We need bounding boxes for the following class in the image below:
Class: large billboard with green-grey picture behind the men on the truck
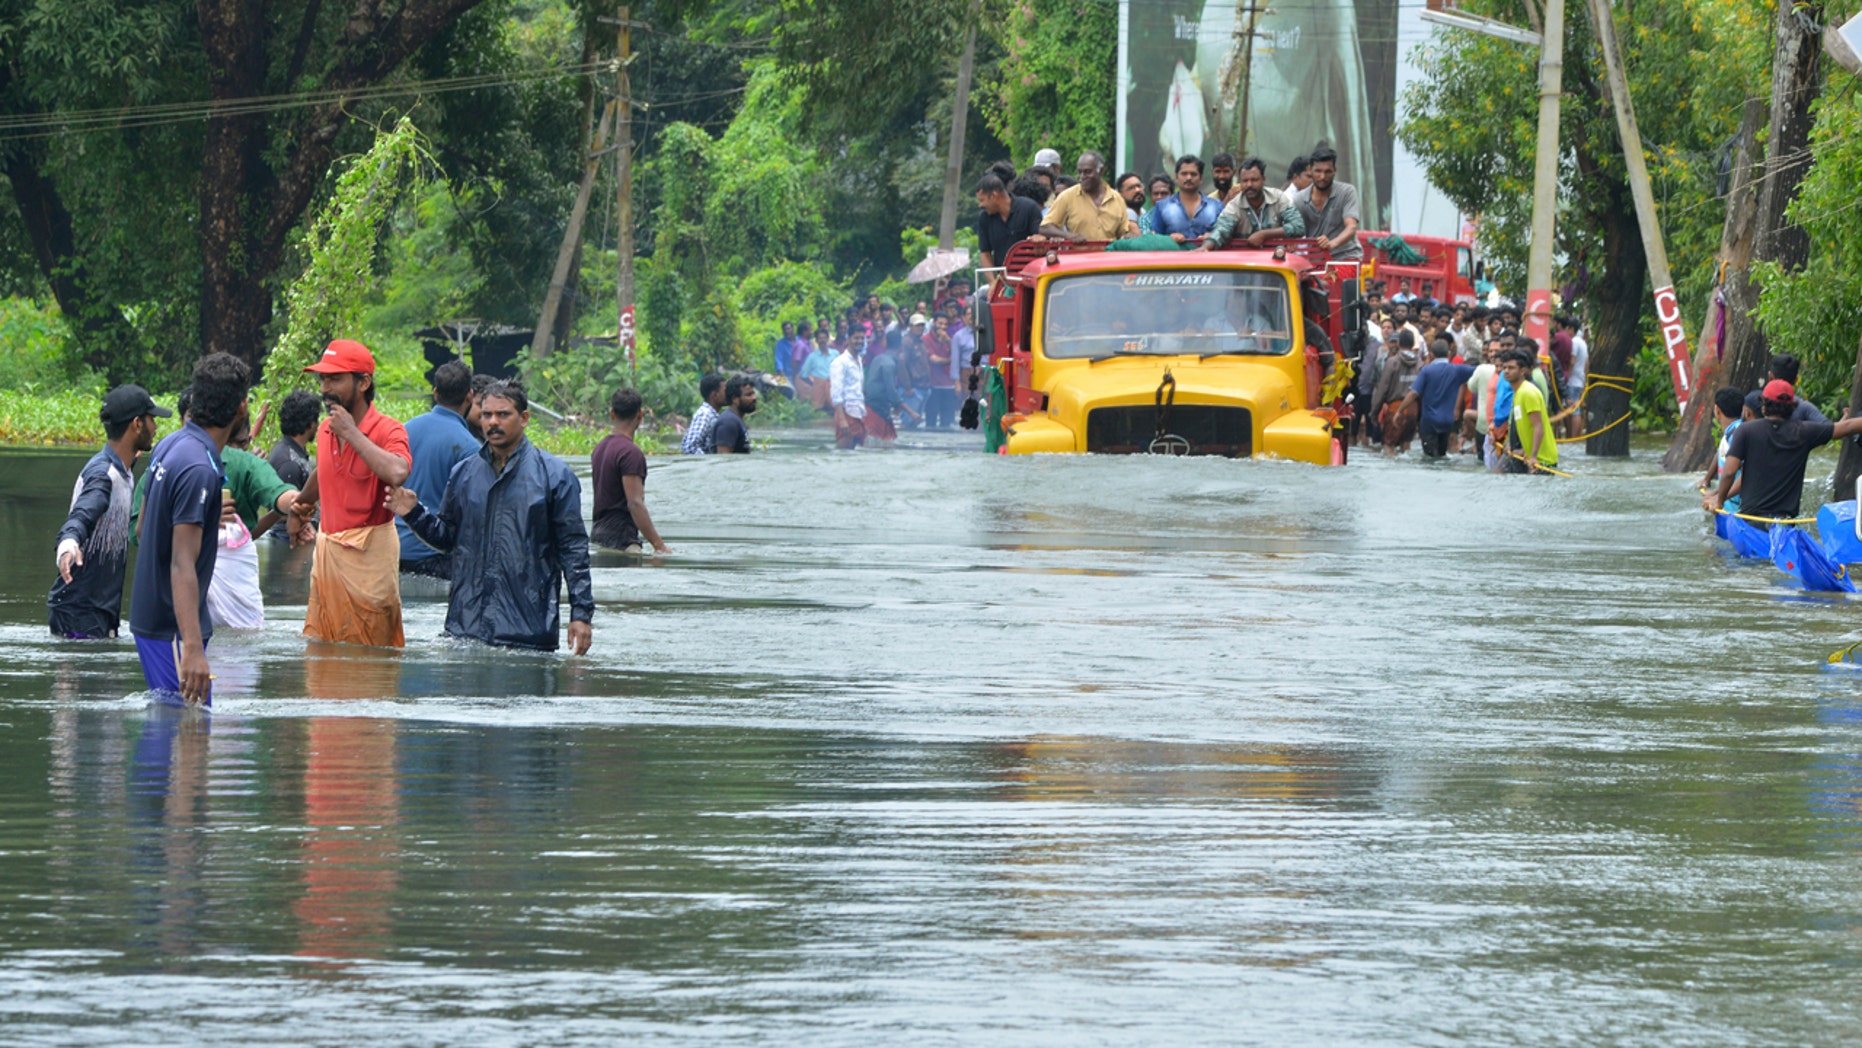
[1117,0,1398,229]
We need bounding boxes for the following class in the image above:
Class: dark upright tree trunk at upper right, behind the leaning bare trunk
[1720,4,1823,405]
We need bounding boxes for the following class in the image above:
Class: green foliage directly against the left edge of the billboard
[978,0,1119,164]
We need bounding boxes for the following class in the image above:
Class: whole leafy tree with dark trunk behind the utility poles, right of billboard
[1398,0,1763,454]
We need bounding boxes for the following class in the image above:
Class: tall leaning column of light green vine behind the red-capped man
[264,117,425,426]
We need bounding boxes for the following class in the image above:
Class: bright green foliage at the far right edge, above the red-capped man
[1754,89,1862,417]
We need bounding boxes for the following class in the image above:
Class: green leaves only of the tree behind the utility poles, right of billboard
[1397,0,1771,309]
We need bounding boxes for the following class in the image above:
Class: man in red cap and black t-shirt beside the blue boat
[1702,378,1862,521]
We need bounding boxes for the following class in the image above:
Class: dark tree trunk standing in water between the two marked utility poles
[1585,182,1648,458]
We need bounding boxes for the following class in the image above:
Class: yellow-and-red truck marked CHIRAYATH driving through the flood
[978,240,1372,465]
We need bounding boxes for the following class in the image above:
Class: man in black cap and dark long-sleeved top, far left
[45,385,173,640]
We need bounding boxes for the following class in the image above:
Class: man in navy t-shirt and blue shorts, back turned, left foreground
[128,354,251,705]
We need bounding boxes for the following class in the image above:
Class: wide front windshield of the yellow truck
[1043,270,1292,359]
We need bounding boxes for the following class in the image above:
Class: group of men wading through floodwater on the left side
[47,339,677,704]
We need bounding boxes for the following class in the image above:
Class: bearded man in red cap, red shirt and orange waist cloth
[292,339,413,648]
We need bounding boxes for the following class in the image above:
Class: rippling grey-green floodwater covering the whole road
[0,434,1862,1046]
